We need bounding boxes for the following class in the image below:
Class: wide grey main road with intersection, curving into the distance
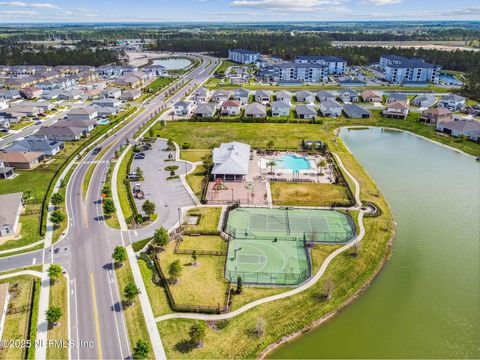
[0,52,218,359]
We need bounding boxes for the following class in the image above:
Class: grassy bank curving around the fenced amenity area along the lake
[154,119,394,358]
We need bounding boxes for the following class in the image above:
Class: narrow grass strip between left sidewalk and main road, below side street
[47,276,69,359]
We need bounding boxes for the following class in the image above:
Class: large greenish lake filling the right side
[270,128,480,358]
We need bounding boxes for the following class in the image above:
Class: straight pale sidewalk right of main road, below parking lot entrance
[127,245,167,360]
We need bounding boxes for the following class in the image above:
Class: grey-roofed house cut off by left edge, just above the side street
[0,192,23,237]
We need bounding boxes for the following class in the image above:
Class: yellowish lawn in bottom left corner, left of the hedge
[0,275,40,359]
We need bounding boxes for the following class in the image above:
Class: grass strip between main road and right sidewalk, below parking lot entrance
[115,260,150,348]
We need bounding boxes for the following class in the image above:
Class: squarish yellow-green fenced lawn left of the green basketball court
[158,243,228,306]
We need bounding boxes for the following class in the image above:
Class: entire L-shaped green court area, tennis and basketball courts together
[225,208,355,285]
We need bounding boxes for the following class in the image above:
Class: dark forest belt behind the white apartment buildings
[147,32,480,72]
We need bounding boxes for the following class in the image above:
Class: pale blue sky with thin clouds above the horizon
[0,0,480,23]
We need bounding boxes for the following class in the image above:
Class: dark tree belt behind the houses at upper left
[0,44,124,66]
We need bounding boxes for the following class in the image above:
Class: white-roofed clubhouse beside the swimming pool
[212,142,250,180]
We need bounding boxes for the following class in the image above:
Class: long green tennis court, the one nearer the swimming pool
[226,208,355,243]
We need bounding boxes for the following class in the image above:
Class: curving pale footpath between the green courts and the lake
[155,150,365,322]
